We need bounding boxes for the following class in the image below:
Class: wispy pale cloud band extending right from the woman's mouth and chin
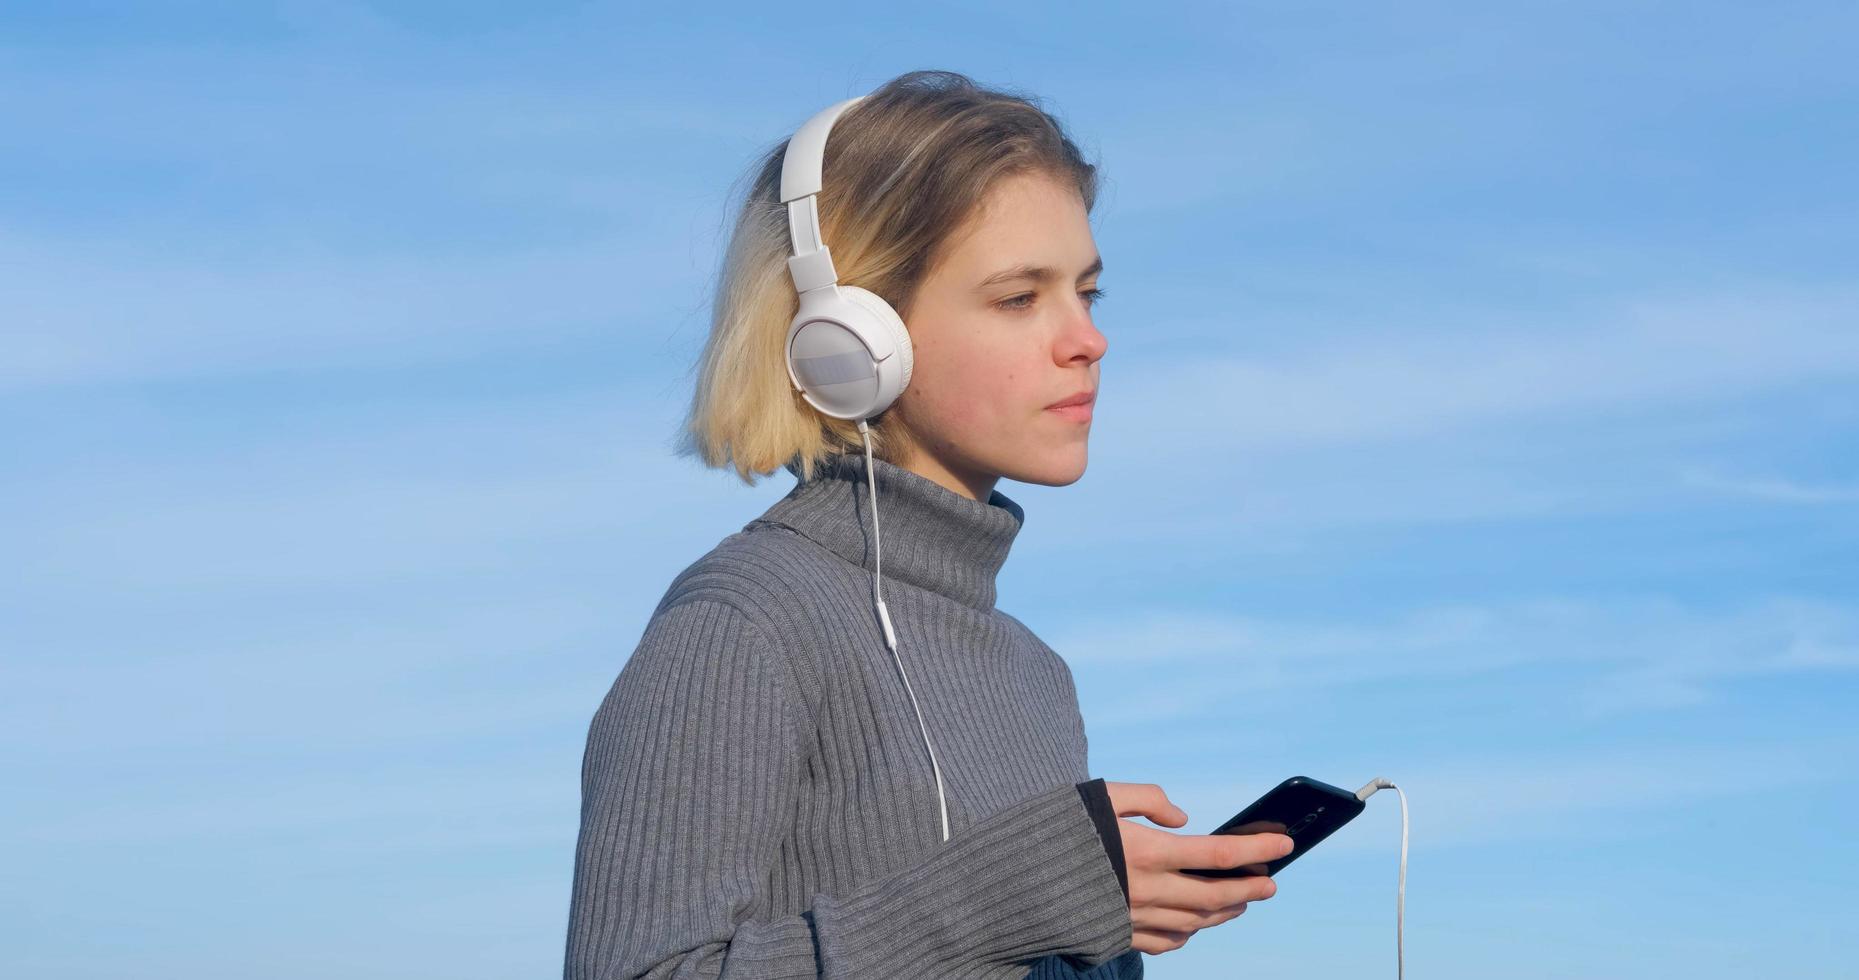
[1101,285,1859,452]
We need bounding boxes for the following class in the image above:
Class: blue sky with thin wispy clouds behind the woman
[0,2,1859,980]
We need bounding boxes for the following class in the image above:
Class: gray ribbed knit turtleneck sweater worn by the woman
[563,454,1143,980]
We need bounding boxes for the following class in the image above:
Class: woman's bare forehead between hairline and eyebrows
[937,173,1097,285]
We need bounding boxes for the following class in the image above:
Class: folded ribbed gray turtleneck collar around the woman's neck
[744,454,1026,610]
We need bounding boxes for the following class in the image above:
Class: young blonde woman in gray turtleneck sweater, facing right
[565,73,1290,980]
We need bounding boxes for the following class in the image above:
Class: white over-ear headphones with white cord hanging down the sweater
[781,95,948,841]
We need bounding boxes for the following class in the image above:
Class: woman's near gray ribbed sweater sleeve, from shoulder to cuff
[563,599,1132,980]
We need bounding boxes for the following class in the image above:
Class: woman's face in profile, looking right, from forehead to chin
[890,175,1108,500]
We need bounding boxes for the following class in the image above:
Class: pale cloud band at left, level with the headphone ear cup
[0,230,705,391]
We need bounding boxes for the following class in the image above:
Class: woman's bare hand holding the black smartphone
[1104,779,1294,954]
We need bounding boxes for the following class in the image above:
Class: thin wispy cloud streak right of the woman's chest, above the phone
[1050,597,1859,725]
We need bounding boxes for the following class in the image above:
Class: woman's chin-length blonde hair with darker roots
[677,71,1097,485]
